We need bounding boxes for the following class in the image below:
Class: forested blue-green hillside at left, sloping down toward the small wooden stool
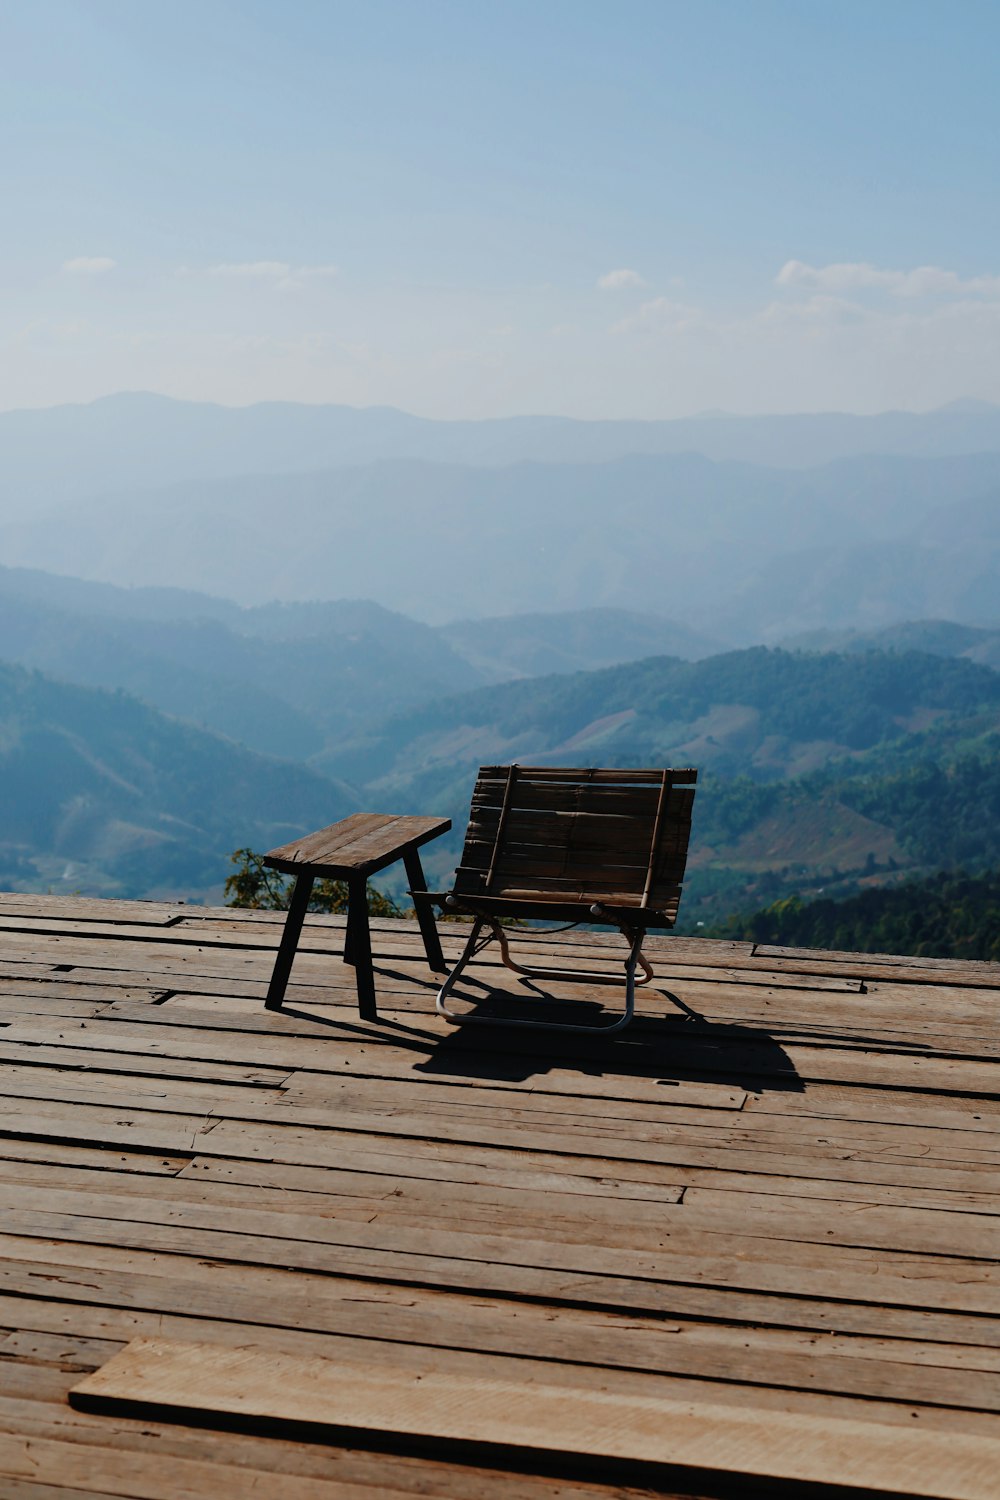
[0,665,357,899]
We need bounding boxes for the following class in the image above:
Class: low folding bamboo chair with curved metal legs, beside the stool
[412,765,697,1035]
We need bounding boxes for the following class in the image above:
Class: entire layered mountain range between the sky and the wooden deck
[0,396,1000,920]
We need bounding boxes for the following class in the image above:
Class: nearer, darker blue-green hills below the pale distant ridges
[0,572,1000,923]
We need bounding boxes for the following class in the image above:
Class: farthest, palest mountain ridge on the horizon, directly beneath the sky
[0,392,1000,509]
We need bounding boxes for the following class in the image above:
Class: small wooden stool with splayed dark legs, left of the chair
[264,813,451,1022]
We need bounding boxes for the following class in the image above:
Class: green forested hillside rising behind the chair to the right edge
[319,648,1000,932]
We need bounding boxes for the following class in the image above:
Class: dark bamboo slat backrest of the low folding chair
[454,765,697,927]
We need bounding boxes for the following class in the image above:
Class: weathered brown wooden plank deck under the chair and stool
[0,896,1000,1500]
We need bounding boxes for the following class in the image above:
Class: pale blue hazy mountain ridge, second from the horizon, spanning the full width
[0,453,1000,630]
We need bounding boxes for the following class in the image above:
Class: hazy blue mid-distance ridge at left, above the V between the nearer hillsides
[0,567,717,761]
